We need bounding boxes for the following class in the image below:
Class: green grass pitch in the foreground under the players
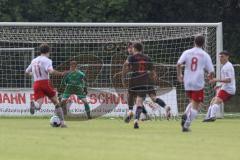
[0,118,240,160]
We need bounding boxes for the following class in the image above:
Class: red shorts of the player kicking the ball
[33,80,56,101]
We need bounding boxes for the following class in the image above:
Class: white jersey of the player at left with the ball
[26,55,53,81]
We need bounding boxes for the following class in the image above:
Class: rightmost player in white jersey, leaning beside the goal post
[203,51,236,122]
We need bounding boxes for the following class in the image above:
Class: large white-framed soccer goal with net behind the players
[0,22,222,116]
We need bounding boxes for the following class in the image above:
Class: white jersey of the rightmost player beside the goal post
[221,61,236,95]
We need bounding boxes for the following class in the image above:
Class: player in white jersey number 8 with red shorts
[177,35,214,132]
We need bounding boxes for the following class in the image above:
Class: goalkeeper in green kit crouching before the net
[61,61,91,119]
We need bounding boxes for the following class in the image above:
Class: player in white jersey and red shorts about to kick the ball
[25,43,66,128]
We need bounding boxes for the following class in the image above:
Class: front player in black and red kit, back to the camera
[127,43,170,129]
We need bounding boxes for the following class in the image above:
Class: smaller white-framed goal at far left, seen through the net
[0,46,34,90]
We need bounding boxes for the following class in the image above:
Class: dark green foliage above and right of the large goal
[0,0,240,55]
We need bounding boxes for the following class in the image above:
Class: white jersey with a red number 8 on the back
[178,47,214,91]
